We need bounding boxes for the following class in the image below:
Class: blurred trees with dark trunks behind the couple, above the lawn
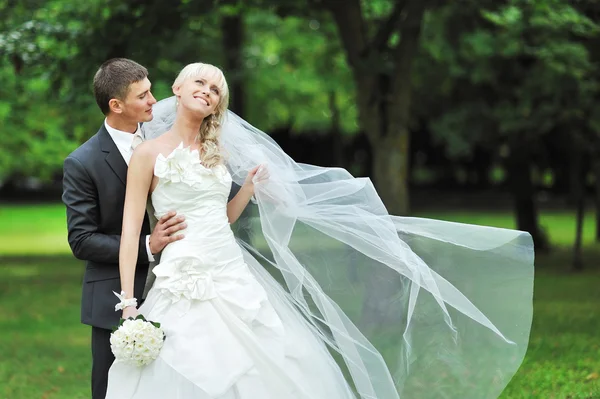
[0,0,600,265]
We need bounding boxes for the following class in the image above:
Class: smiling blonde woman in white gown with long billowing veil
[106,63,533,399]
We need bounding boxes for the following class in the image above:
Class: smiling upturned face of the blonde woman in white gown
[174,76,221,118]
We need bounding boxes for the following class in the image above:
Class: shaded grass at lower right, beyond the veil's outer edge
[502,268,600,399]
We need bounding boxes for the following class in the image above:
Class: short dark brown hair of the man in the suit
[94,58,148,115]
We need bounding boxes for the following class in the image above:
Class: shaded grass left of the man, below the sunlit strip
[0,256,91,399]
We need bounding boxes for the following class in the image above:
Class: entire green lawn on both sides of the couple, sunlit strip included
[0,205,600,399]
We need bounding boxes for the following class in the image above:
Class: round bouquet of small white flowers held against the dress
[110,315,165,367]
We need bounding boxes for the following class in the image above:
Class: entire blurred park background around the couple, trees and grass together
[0,0,600,399]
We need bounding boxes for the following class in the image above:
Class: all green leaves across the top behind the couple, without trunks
[0,0,600,191]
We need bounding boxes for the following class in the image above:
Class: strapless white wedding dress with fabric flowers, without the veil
[106,146,355,399]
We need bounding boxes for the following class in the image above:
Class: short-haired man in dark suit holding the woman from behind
[62,58,184,399]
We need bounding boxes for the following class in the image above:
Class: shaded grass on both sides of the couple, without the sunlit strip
[0,255,600,399]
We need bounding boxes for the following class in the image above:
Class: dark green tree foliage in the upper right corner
[416,0,600,159]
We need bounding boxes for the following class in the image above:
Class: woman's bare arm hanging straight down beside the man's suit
[119,142,156,306]
